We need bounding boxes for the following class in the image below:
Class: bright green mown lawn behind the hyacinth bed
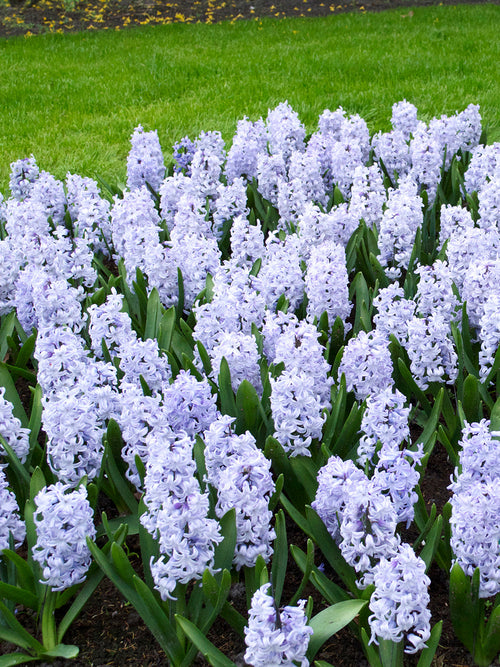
[0,5,500,193]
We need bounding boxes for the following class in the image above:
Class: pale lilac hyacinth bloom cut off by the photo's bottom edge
[245,584,313,667]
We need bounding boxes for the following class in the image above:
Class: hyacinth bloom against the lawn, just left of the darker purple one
[127,125,165,192]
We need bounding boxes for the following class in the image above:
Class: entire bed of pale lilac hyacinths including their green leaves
[0,101,500,667]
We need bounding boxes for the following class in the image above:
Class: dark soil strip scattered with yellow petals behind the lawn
[0,0,500,37]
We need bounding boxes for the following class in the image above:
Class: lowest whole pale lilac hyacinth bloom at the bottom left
[33,482,96,591]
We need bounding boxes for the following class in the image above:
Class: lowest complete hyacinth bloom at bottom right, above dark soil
[368,543,431,654]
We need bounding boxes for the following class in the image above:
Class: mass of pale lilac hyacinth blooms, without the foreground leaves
[0,101,500,667]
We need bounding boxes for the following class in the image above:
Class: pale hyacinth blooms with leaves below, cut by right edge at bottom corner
[449,419,500,667]
